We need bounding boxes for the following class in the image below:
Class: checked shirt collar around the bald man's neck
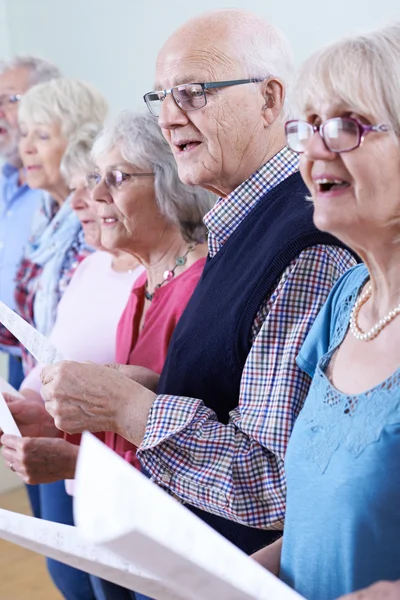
[204,147,299,257]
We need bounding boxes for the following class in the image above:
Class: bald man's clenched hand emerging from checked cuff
[41,361,155,446]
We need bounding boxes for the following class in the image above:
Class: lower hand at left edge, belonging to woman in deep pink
[1,435,79,484]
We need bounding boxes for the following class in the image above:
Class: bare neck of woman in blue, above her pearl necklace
[356,242,400,320]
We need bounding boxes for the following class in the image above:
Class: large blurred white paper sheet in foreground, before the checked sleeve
[74,433,301,600]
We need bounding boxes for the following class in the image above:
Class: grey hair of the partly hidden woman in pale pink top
[60,123,102,183]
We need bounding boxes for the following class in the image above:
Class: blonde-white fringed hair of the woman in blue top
[295,22,400,136]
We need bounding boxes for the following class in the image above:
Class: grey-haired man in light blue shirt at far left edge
[0,57,60,389]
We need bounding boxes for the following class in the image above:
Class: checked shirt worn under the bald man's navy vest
[138,148,355,529]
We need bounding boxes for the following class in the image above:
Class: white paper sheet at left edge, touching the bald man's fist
[0,302,63,365]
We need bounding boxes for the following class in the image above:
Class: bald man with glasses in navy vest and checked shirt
[43,10,355,553]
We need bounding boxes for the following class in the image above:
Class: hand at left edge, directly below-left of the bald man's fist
[0,393,60,437]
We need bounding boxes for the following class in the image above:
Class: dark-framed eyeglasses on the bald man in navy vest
[143,79,264,117]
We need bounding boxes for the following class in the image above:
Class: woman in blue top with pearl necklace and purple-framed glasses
[254,23,400,600]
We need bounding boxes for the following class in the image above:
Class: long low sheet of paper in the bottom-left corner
[0,509,186,600]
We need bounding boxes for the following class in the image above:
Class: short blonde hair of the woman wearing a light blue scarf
[18,77,108,141]
